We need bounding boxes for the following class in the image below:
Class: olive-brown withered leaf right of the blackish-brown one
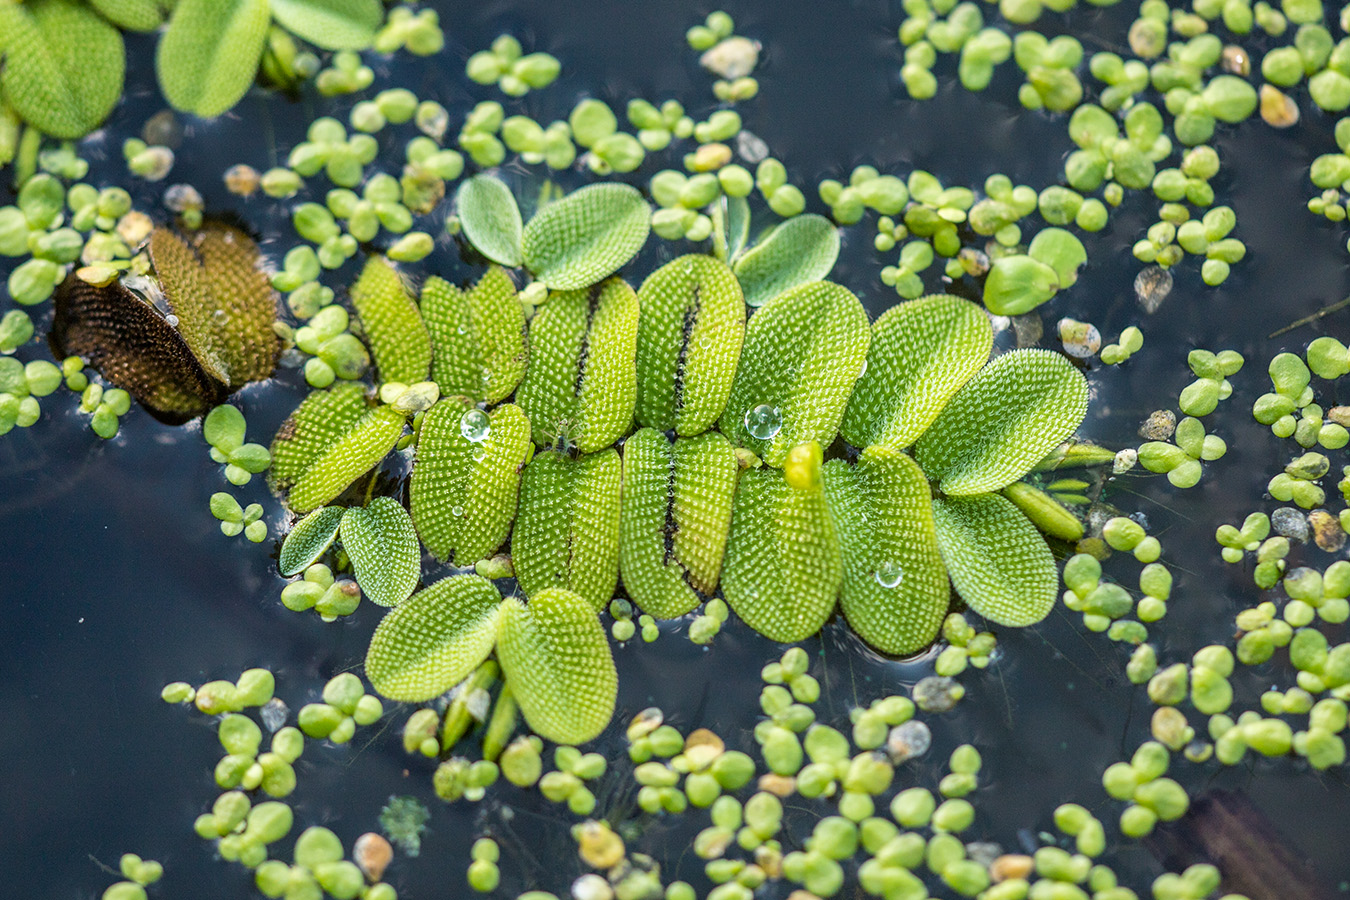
[150,221,281,390]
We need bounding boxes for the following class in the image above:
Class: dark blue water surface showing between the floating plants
[0,0,1350,899]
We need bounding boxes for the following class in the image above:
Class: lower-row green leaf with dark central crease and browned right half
[620,428,740,619]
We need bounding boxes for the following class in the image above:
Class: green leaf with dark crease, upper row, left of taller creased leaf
[516,278,639,453]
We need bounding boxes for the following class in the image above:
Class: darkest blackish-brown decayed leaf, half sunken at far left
[49,274,225,425]
